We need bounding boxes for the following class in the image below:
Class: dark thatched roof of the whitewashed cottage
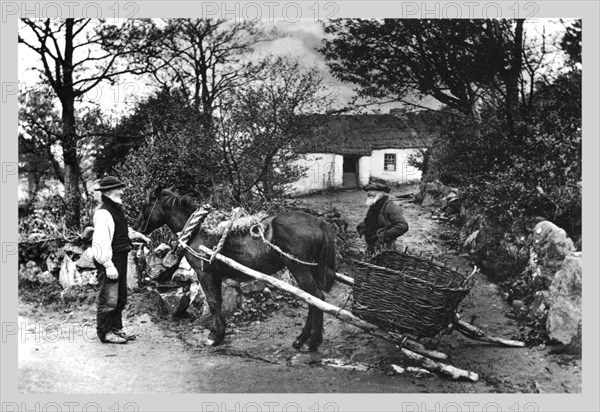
[297,113,438,156]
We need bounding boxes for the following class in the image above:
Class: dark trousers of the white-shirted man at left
[96,252,128,339]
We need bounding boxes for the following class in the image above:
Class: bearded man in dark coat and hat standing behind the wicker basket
[356,183,408,254]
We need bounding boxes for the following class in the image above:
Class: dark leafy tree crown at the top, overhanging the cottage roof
[320,19,522,115]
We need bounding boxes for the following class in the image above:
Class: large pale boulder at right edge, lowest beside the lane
[546,252,582,345]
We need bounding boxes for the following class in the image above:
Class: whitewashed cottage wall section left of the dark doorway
[291,153,344,194]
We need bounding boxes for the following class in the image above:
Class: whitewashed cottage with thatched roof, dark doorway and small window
[292,110,437,194]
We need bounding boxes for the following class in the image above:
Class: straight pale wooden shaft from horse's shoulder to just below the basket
[198,245,448,360]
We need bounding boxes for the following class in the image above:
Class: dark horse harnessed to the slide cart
[135,187,335,351]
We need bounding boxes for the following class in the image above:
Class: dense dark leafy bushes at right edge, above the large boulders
[434,72,582,241]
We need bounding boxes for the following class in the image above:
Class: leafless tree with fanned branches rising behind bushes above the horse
[138,19,270,134]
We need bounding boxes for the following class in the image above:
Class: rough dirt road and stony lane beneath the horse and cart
[19,186,582,393]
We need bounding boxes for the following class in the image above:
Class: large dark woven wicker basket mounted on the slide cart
[352,250,473,338]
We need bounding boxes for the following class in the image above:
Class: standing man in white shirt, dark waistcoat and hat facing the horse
[92,176,150,343]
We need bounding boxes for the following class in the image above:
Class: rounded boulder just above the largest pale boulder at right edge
[530,220,575,278]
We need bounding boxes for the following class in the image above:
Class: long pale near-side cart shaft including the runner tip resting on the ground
[188,245,488,382]
